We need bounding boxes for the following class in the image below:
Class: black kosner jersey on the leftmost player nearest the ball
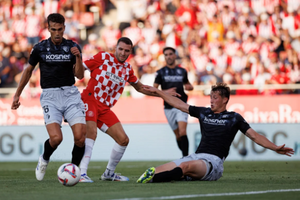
[29,38,81,88]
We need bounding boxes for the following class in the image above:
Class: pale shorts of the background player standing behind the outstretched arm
[164,108,189,131]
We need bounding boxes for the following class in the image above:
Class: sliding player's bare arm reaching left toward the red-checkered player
[144,85,190,113]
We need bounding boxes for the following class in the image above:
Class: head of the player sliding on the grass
[210,83,230,113]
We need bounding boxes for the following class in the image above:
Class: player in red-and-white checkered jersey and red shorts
[80,37,164,183]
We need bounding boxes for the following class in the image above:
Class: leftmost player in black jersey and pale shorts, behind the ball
[11,13,86,181]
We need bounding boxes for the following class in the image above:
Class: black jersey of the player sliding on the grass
[189,106,250,159]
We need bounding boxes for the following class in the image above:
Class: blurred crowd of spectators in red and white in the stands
[0,0,300,97]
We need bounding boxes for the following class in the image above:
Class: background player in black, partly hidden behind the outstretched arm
[153,47,194,156]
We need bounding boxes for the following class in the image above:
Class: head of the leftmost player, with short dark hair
[47,13,65,44]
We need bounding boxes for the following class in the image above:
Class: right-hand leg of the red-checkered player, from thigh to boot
[101,122,129,181]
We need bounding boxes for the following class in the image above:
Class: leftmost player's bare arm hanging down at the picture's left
[11,64,34,110]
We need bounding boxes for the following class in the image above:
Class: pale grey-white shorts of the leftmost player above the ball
[40,86,85,126]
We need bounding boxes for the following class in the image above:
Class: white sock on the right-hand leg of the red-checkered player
[105,143,127,175]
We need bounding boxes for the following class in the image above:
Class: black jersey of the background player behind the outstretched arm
[154,66,189,109]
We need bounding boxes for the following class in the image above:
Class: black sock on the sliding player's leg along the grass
[152,167,183,183]
